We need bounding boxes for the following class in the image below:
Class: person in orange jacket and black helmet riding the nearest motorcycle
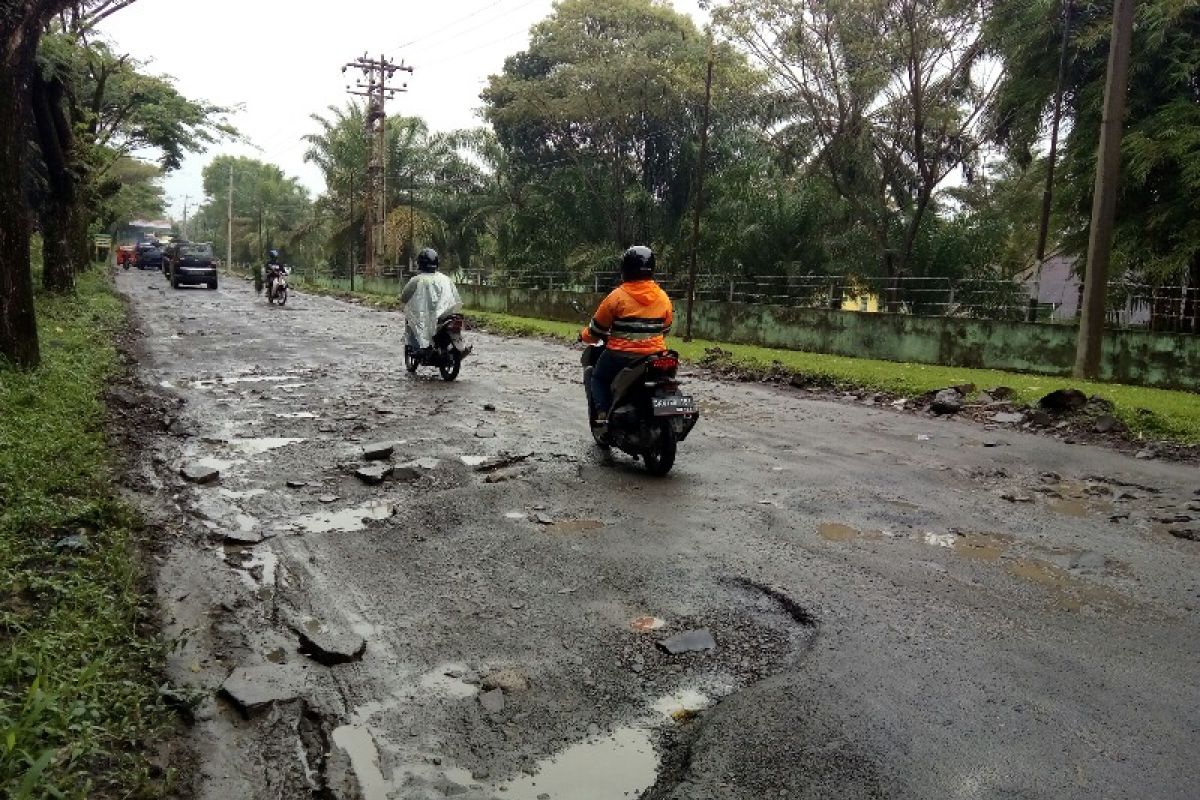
[580,246,674,423]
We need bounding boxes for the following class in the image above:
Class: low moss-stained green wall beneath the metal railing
[460,284,1200,391]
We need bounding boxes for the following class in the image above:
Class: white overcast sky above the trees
[103,0,706,217]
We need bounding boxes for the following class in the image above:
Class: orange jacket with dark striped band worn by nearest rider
[582,281,673,355]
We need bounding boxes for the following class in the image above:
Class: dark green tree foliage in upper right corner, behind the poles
[988,0,1200,285]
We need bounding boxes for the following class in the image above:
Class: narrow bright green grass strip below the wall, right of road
[290,282,1200,445]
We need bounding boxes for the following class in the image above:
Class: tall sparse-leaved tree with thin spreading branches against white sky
[714,0,996,287]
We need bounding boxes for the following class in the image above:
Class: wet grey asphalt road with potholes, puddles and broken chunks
[118,272,1200,800]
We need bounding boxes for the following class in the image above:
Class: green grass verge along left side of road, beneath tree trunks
[0,269,172,798]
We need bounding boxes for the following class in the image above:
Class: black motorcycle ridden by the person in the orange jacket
[582,347,700,475]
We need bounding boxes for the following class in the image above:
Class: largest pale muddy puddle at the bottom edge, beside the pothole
[502,728,659,800]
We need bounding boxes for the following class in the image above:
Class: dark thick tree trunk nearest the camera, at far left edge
[0,14,41,369]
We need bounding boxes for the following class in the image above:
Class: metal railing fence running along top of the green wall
[283,266,1200,333]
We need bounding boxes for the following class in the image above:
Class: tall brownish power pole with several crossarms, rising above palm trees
[342,53,413,276]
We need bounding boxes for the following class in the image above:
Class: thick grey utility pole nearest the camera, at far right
[1075,0,1135,378]
